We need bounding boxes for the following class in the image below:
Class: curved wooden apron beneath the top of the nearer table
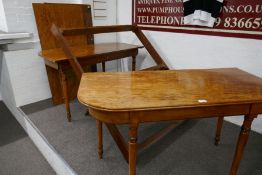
[89,104,254,124]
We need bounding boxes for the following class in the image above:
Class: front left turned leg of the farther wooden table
[59,68,71,122]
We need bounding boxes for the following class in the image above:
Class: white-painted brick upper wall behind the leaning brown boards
[0,0,116,42]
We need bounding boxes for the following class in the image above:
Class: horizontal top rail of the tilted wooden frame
[62,25,135,36]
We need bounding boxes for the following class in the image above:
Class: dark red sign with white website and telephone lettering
[133,0,262,39]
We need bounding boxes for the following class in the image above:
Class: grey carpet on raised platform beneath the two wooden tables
[24,101,262,175]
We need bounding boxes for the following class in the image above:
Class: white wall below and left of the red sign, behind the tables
[118,1,262,133]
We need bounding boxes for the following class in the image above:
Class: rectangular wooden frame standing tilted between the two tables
[51,24,173,160]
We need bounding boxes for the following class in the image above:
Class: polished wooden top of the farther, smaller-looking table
[39,43,142,63]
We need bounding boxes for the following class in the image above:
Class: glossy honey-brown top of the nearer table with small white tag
[78,68,262,111]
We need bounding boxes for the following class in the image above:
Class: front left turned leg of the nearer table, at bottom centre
[128,124,138,175]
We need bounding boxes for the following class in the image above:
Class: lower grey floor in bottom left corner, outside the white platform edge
[0,102,55,175]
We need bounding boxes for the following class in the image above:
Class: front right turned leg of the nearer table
[230,115,256,175]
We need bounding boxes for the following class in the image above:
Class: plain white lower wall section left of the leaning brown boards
[2,49,51,106]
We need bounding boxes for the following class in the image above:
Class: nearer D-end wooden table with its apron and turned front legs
[78,68,262,175]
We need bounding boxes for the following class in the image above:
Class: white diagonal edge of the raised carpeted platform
[4,101,77,175]
